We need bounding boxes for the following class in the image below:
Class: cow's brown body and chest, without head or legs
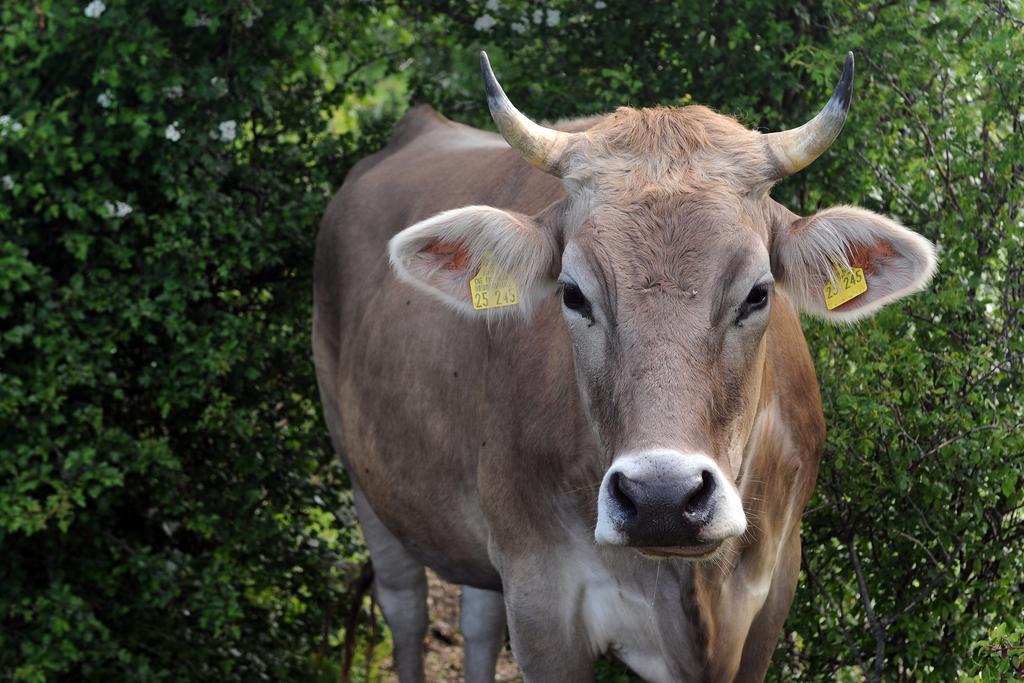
[315,108,824,681]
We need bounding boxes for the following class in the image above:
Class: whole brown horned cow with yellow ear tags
[313,53,936,683]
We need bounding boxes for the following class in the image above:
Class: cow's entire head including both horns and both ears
[390,54,935,557]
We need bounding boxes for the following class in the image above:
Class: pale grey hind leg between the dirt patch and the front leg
[459,586,505,683]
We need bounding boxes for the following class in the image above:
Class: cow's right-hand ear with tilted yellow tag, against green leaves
[771,206,936,322]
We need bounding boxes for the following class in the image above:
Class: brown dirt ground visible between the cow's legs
[380,570,522,683]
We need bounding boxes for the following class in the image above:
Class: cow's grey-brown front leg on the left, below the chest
[505,577,594,683]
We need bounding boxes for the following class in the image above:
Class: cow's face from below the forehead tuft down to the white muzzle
[558,183,775,556]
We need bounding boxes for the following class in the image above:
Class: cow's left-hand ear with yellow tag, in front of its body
[388,206,558,315]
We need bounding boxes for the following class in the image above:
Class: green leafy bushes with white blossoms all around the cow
[0,0,1024,681]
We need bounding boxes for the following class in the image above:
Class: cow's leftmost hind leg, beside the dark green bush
[353,486,428,683]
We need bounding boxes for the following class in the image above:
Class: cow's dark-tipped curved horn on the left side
[480,51,578,176]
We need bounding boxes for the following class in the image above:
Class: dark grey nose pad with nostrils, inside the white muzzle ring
[606,469,715,547]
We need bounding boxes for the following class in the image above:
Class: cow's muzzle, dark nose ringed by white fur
[594,451,746,557]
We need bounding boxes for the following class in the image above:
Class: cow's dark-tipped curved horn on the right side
[765,52,853,178]
